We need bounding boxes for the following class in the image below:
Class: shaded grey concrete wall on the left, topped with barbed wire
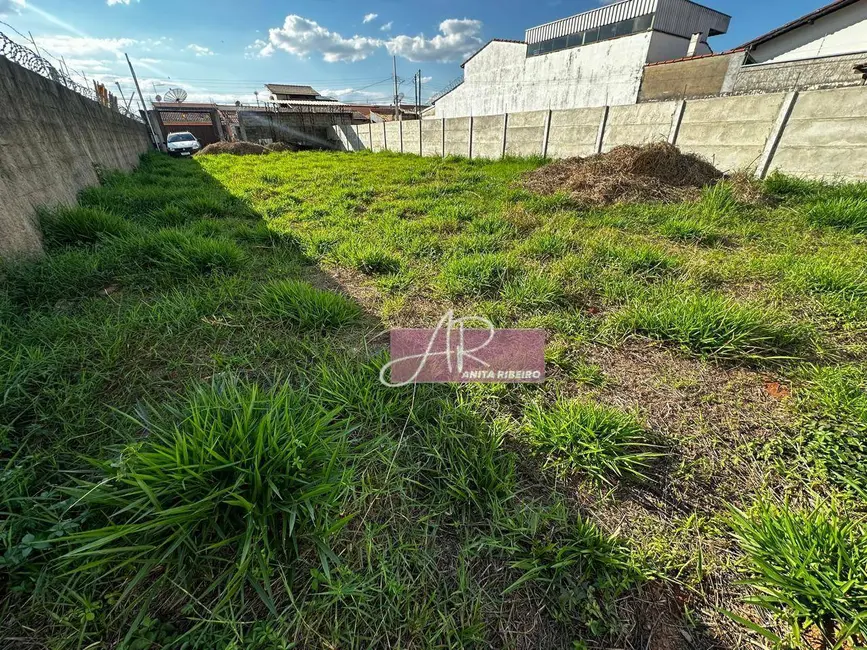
[0,56,151,255]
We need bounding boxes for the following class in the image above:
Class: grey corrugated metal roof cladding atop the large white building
[525,0,731,44]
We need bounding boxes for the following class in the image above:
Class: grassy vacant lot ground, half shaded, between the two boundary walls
[0,153,867,650]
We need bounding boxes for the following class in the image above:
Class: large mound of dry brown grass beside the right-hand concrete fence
[523,142,724,205]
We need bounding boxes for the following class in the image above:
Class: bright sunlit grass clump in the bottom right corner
[731,501,867,648]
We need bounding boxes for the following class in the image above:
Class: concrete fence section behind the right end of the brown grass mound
[680,93,785,171]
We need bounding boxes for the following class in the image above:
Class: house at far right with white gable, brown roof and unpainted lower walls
[639,0,867,101]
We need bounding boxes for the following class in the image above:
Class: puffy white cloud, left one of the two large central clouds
[259,14,383,63]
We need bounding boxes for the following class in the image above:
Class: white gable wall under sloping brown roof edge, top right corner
[750,0,867,63]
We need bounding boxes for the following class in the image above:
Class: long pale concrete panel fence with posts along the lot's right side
[332,88,867,181]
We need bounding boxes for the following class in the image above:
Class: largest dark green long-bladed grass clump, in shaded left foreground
[61,380,349,613]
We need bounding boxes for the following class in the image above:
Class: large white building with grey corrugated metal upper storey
[434,0,731,118]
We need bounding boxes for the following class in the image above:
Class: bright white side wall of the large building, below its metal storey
[436,32,656,118]
